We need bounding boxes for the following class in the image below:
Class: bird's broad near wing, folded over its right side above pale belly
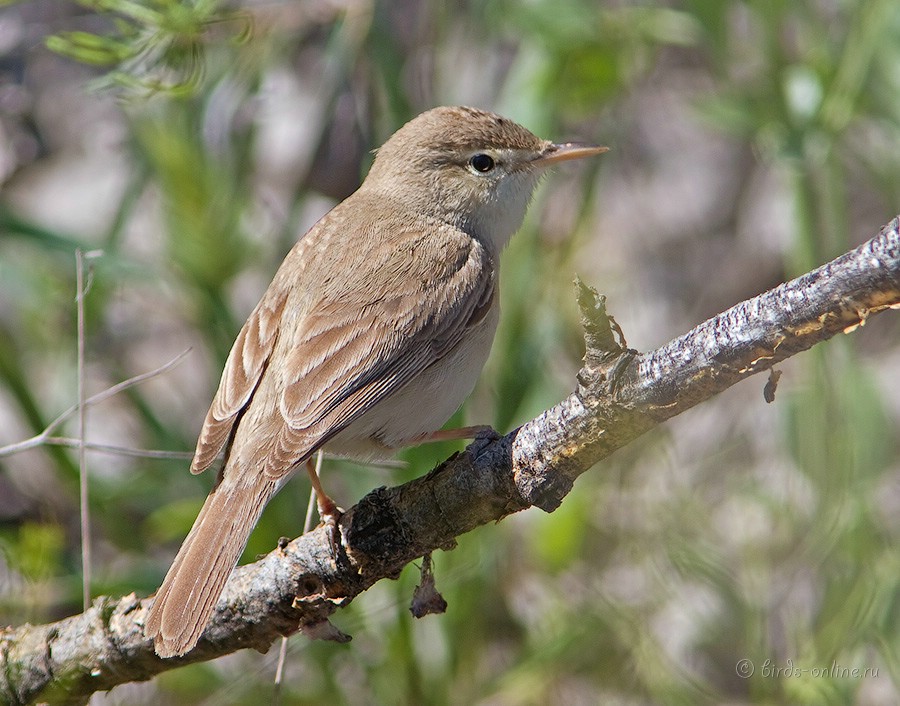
[264,226,494,476]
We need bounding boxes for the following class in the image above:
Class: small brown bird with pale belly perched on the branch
[145,108,606,657]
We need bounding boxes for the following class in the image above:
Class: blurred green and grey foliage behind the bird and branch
[0,0,900,706]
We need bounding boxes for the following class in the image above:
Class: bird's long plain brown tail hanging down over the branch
[144,474,279,657]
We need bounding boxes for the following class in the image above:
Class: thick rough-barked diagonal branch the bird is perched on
[0,214,900,704]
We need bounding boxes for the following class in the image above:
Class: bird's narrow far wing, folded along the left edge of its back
[191,287,288,473]
